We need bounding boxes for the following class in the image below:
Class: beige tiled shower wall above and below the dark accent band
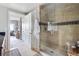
[40,3,79,55]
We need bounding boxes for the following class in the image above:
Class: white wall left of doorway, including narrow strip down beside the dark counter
[0,6,9,51]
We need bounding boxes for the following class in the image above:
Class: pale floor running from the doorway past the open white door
[10,36,36,56]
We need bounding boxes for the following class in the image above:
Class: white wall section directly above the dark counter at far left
[0,6,8,32]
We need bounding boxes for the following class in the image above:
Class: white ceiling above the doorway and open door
[0,3,42,13]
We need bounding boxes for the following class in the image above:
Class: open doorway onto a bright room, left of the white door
[8,11,22,49]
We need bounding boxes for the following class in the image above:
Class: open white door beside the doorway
[22,13,31,48]
